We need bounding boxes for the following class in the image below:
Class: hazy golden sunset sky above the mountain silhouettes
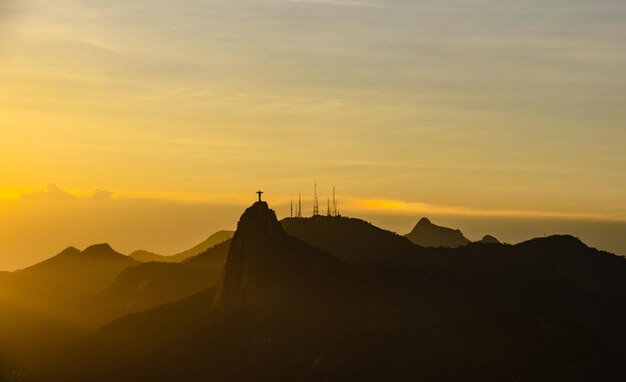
[0,0,626,270]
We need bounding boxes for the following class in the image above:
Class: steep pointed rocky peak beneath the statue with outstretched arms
[214,202,340,310]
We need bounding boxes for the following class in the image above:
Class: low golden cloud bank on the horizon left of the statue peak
[0,185,244,270]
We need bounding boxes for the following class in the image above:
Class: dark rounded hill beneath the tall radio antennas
[281,216,417,264]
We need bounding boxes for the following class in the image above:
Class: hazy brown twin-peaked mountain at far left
[15,244,138,292]
